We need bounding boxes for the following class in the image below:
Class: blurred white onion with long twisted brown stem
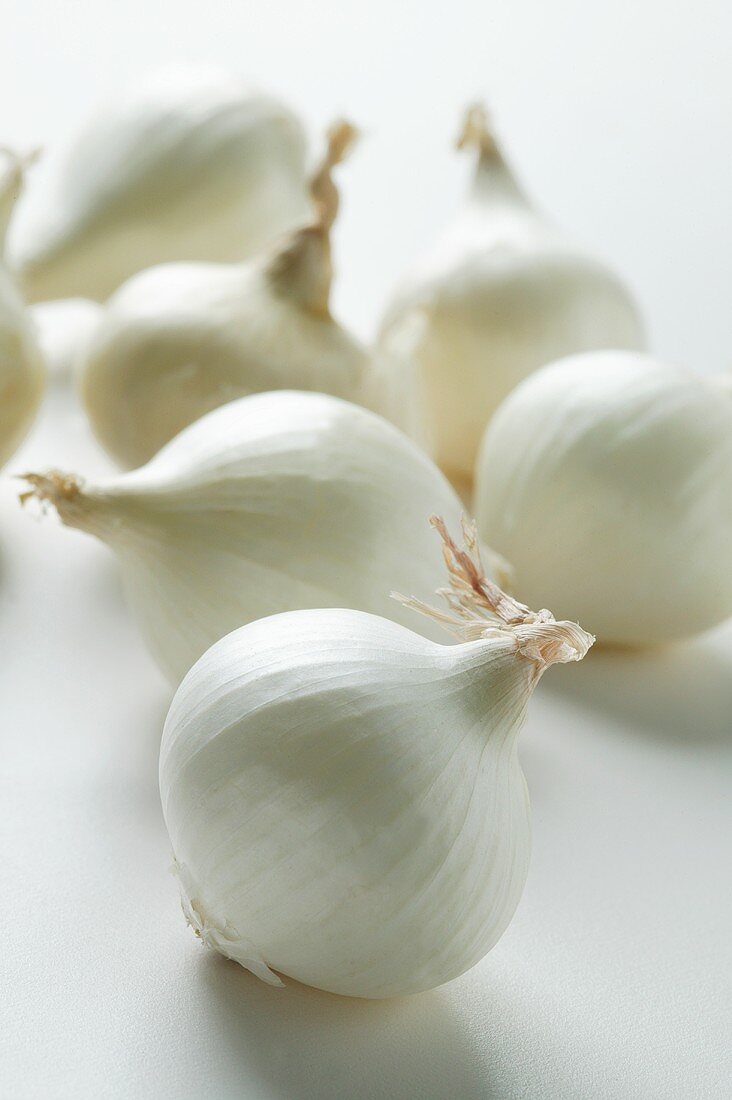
[78,122,369,468]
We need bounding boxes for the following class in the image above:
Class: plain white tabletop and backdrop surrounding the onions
[0,0,732,1100]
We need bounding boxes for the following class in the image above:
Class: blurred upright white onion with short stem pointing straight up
[380,107,644,491]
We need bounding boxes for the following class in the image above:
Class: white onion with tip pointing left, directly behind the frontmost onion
[24,391,499,683]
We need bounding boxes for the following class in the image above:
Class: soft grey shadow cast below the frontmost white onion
[199,952,494,1100]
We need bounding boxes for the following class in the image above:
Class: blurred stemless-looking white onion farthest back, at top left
[11,66,308,301]
